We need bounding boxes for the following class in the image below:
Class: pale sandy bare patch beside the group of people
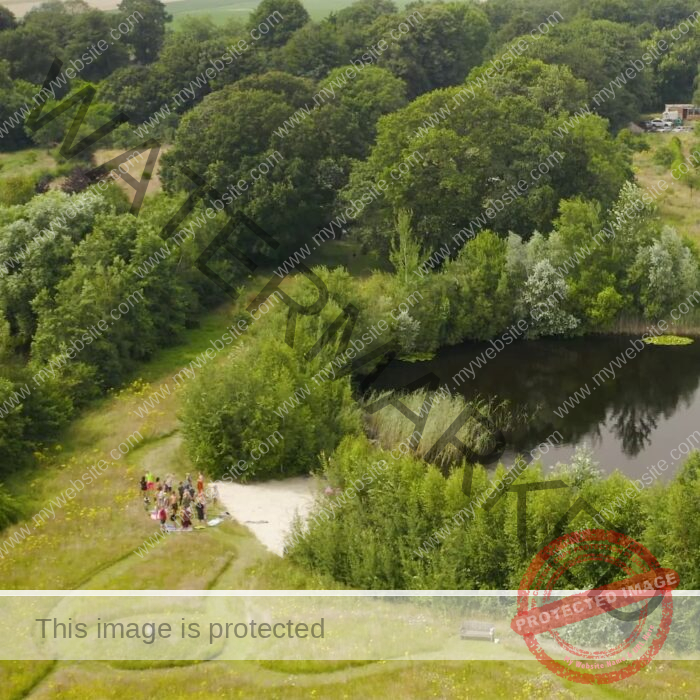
[216,476,317,556]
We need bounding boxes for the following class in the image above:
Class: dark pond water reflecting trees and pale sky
[372,336,700,477]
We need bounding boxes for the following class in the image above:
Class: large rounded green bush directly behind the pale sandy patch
[183,337,359,481]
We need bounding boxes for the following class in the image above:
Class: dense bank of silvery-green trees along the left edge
[0,186,235,470]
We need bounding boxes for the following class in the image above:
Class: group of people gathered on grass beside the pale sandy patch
[140,472,207,530]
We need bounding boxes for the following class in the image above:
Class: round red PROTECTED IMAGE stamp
[511,530,680,683]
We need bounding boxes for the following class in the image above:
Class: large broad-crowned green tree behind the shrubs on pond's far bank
[341,60,631,249]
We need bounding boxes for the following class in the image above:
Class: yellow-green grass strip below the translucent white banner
[1,661,697,700]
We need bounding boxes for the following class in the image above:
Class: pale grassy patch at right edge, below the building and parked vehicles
[634,132,700,244]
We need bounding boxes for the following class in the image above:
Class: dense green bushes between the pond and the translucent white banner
[290,438,700,590]
